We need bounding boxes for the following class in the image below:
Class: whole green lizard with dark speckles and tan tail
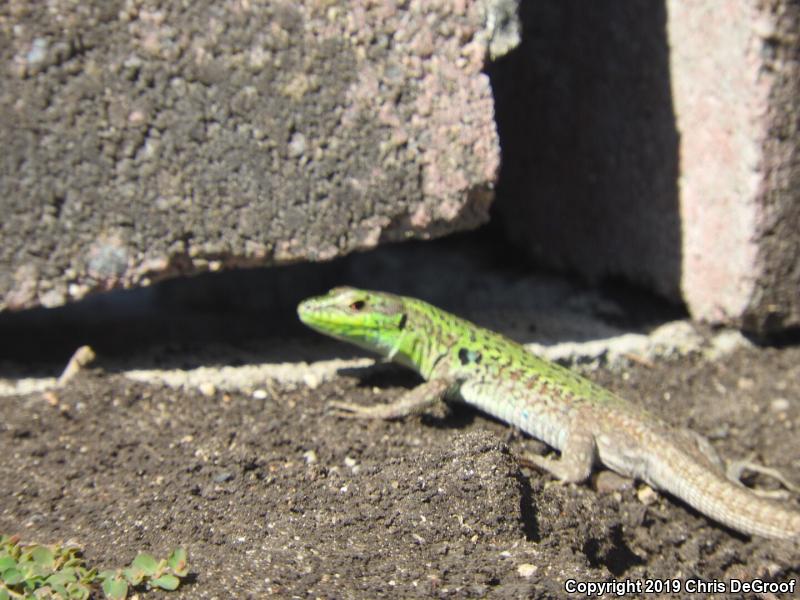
[297,287,800,540]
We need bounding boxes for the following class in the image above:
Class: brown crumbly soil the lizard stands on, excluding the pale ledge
[0,340,800,598]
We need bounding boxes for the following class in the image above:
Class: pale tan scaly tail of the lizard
[652,455,800,540]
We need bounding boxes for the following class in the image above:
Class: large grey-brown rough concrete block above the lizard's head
[0,0,518,310]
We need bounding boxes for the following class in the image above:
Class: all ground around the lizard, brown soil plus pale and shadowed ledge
[0,237,800,598]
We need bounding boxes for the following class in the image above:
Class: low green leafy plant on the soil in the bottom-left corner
[0,535,189,600]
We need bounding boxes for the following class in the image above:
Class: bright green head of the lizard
[297,287,407,359]
